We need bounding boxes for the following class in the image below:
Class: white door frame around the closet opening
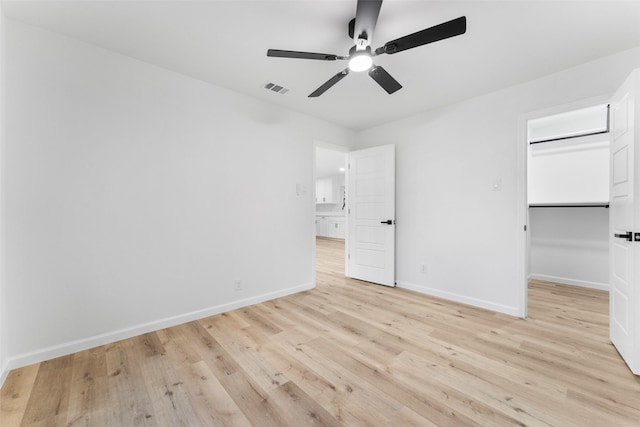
[517,96,610,318]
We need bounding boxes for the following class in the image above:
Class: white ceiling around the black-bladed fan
[2,0,640,130]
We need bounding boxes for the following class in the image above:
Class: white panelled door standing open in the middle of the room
[346,145,396,286]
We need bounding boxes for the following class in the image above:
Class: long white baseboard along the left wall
[0,283,315,376]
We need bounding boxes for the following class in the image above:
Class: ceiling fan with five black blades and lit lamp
[267,0,467,98]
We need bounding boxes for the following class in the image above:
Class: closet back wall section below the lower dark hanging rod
[529,207,609,289]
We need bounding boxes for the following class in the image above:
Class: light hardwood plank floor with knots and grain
[0,239,640,427]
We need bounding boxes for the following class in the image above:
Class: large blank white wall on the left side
[3,20,354,368]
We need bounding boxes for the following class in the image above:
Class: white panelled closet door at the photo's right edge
[609,70,640,375]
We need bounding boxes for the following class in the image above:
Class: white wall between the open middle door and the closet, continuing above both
[358,48,640,315]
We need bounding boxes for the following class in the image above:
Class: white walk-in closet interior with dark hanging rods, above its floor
[527,104,609,289]
